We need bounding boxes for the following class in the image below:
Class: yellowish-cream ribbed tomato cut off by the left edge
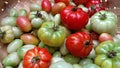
[0,25,15,43]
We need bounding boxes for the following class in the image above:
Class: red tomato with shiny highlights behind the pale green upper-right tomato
[86,0,105,16]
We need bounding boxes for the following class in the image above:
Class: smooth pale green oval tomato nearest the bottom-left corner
[3,52,20,67]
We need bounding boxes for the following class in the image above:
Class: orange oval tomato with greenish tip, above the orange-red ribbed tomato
[20,34,39,45]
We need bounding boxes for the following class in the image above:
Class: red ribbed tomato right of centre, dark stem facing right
[66,32,92,58]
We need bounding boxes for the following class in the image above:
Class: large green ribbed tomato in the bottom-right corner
[94,40,120,68]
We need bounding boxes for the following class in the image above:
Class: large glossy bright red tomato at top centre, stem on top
[60,6,89,30]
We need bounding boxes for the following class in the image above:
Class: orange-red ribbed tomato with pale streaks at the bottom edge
[23,47,52,68]
